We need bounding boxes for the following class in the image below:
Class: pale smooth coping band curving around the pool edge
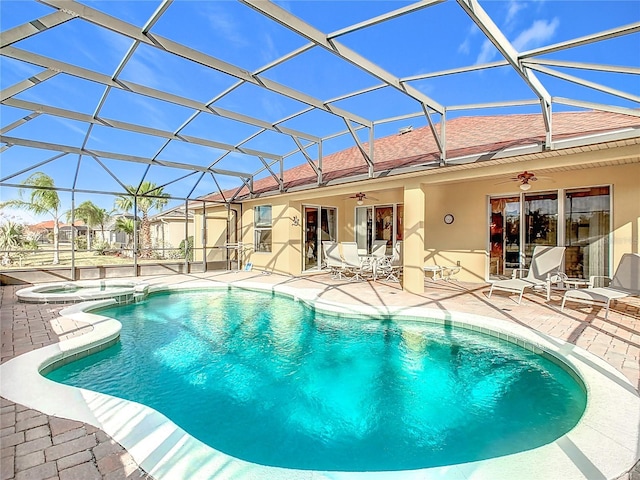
[0,281,640,480]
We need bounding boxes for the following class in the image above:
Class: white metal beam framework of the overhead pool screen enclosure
[0,0,640,274]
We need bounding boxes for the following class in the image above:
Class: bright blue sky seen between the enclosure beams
[0,0,640,223]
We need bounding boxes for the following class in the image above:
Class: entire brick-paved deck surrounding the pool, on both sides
[0,272,640,480]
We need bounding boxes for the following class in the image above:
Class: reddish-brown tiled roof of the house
[204,111,640,200]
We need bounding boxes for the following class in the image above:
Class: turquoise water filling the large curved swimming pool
[47,290,586,471]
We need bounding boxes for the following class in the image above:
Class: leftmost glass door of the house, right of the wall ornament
[302,206,338,271]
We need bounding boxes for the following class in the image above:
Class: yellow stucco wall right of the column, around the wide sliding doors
[425,163,640,281]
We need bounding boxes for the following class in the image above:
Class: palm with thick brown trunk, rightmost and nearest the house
[116,181,169,258]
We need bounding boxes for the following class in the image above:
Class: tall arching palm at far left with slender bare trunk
[0,172,61,265]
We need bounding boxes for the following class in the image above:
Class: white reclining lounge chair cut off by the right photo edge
[561,253,640,320]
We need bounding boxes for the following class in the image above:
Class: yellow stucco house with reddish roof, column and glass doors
[195,111,640,292]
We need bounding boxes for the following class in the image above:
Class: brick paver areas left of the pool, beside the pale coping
[0,286,151,480]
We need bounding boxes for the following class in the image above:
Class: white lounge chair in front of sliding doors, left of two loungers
[489,245,565,305]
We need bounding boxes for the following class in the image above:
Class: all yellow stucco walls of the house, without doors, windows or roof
[202,147,640,282]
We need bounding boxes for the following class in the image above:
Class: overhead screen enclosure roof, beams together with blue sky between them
[0,0,640,208]
